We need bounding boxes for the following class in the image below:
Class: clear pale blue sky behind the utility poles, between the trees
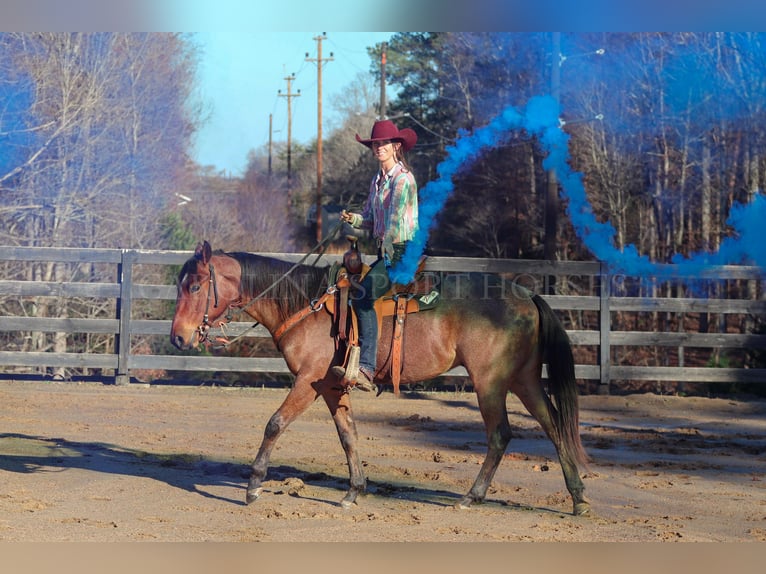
[191,31,392,177]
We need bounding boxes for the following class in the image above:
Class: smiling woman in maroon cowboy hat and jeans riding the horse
[334,120,418,391]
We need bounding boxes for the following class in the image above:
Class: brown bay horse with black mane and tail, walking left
[170,241,590,516]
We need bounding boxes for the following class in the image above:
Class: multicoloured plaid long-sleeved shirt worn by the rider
[354,162,418,243]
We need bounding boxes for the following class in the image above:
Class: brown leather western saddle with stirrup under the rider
[325,236,439,396]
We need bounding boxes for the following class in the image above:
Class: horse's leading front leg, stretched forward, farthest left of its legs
[245,376,318,504]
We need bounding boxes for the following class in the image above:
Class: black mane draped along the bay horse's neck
[226,252,328,319]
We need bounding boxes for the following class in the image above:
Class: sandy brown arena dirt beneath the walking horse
[0,381,766,542]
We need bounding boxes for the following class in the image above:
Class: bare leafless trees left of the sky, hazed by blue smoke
[0,33,201,380]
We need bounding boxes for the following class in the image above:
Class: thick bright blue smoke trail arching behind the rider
[391,96,766,284]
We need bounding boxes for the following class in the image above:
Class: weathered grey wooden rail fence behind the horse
[0,247,766,393]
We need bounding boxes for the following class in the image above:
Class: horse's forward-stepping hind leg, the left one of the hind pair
[457,387,511,508]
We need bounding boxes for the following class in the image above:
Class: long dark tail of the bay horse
[532,295,588,466]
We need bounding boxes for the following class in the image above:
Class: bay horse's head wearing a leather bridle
[170,241,241,349]
